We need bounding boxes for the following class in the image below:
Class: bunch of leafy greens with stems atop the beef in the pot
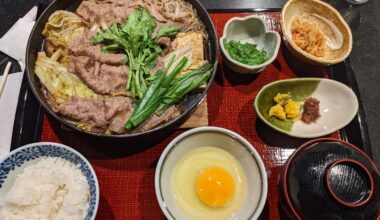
[91,7,180,99]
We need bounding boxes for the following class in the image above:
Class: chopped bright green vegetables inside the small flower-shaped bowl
[224,40,268,65]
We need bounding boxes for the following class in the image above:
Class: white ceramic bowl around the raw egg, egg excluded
[155,127,268,220]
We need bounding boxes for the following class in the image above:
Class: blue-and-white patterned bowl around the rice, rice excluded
[0,142,100,220]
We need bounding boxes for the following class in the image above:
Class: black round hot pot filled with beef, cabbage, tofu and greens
[26,0,218,141]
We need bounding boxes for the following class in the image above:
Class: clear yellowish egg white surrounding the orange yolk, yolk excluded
[171,147,247,220]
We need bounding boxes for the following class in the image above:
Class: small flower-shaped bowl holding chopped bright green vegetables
[219,16,281,73]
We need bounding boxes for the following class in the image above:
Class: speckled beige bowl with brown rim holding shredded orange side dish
[281,0,352,66]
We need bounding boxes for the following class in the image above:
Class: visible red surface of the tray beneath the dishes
[37,12,339,220]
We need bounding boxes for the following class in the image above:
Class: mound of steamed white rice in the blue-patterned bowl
[0,158,90,220]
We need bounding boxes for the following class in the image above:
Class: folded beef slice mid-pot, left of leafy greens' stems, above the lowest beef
[68,56,128,95]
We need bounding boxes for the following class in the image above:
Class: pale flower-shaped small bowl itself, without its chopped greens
[219,16,281,73]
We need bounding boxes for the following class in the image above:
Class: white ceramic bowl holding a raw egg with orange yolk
[155,127,268,220]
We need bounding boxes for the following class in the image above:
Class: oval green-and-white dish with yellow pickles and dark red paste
[254,78,358,138]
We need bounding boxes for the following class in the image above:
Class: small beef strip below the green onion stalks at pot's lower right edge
[134,105,179,133]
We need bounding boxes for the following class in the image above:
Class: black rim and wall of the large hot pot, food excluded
[26,0,219,143]
